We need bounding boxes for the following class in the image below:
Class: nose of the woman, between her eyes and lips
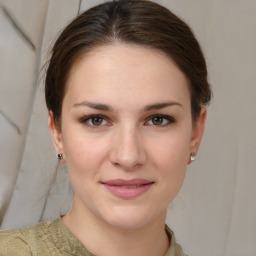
[110,127,147,171]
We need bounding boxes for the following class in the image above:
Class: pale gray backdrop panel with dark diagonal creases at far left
[0,0,48,222]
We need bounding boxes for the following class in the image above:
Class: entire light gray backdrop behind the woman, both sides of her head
[0,0,256,256]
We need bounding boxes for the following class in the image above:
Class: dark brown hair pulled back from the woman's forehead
[45,0,211,127]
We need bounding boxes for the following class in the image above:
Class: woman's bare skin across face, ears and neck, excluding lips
[49,44,206,256]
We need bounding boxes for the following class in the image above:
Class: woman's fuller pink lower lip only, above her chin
[104,183,153,199]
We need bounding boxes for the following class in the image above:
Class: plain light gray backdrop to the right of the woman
[162,0,256,256]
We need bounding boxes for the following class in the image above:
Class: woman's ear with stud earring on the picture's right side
[188,107,207,164]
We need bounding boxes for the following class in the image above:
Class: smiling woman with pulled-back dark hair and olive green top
[0,0,211,256]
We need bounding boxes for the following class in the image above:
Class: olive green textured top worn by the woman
[0,218,186,256]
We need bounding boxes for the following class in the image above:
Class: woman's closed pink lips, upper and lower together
[102,179,154,199]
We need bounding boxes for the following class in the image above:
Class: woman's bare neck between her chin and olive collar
[62,195,169,256]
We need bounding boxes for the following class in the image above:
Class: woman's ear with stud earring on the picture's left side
[48,111,65,162]
